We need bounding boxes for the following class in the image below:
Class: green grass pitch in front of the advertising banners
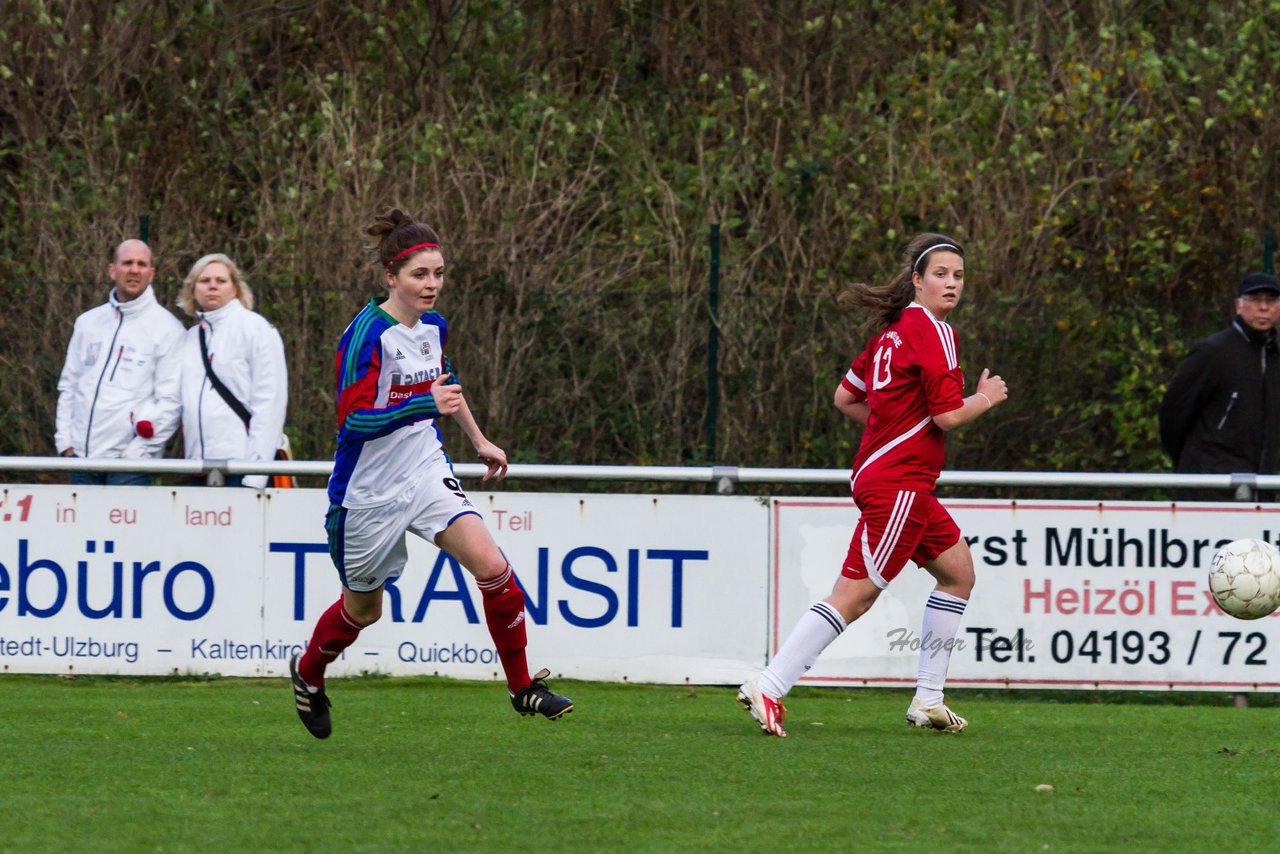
[0,676,1280,851]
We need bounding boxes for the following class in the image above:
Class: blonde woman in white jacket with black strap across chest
[178,254,288,488]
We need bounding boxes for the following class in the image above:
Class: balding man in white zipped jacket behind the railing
[54,239,183,485]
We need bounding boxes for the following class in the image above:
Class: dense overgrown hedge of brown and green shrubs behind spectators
[0,0,1280,481]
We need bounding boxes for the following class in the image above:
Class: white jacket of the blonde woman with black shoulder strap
[182,298,289,487]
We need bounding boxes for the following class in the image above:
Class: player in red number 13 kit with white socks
[737,234,1009,736]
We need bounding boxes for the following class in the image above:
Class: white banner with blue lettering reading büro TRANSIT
[0,485,769,682]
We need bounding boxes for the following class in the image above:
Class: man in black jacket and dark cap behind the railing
[1160,273,1280,501]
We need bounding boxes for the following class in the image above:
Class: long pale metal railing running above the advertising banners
[0,457,1280,494]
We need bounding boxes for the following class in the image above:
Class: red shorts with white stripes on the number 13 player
[840,490,960,590]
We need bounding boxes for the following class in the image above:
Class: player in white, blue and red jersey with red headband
[289,210,573,739]
